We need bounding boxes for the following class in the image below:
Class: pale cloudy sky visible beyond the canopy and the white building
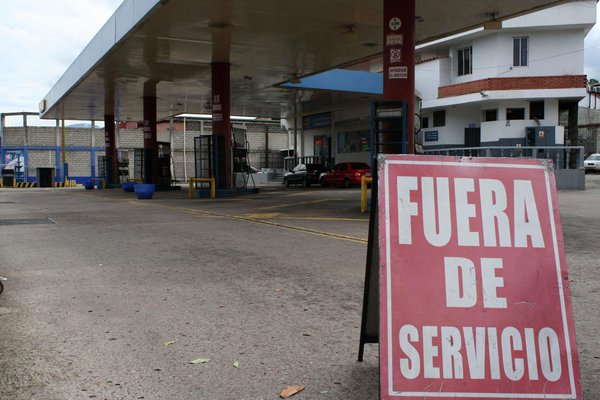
[0,0,600,125]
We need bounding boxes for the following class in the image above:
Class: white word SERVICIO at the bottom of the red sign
[398,325,562,382]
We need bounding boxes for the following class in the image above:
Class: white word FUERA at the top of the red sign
[397,176,544,248]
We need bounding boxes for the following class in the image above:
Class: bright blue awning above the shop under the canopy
[280,69,383,95]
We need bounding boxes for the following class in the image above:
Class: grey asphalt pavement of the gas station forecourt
[0,175,600,400]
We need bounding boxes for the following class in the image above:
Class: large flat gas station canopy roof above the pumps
[40,0,566,121]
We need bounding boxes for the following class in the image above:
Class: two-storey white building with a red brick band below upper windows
[416,1,596,149]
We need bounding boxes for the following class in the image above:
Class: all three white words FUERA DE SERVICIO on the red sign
[397,176,562,382]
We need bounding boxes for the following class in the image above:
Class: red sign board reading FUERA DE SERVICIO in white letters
[379,155,582,399]
